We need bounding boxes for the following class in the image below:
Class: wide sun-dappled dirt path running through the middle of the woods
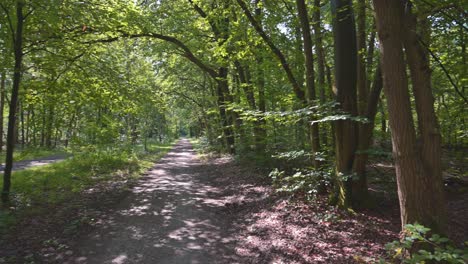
[66,139,245,264]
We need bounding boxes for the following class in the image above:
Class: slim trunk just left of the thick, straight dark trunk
[296,0,320,169]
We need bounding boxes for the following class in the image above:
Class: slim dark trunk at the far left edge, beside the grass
[2,1,24,203]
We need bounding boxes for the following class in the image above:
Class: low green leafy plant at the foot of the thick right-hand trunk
[381,223,468,264]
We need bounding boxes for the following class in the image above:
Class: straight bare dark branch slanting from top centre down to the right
[237,0,306,102]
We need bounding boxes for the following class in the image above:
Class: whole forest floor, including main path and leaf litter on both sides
[0,139,467,264]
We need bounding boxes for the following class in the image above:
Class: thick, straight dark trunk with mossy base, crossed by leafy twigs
[331,0,358,207]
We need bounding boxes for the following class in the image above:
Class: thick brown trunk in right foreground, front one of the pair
[373,0,444,232]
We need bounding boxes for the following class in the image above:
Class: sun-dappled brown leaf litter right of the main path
[236,201,398,263]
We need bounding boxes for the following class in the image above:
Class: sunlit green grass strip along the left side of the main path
[0,139,172,233]
